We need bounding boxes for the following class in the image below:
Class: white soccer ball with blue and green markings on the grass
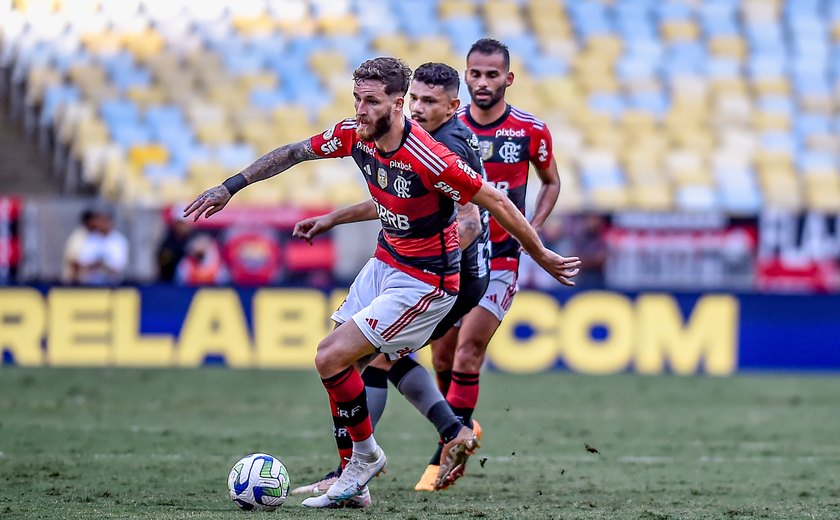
[228,453,289,511]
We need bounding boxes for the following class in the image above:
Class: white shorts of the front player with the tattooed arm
[331,258,456,361]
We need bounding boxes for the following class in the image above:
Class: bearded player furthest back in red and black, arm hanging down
[415,38,560,491]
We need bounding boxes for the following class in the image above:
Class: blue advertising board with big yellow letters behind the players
[0,286,840,375]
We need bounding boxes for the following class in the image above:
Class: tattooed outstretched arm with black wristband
[184,139,319,220]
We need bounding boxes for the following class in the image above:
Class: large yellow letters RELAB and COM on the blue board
[0,288,739,375]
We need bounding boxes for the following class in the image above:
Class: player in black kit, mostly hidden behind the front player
[292,63,490,500]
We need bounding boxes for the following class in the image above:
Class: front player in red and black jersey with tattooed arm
[184,57,580,507]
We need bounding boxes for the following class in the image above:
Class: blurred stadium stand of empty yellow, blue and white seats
[0,0,840,214]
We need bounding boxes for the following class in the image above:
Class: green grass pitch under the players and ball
[0,367,840,520]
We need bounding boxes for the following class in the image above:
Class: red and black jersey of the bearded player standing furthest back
[458,105,553,271]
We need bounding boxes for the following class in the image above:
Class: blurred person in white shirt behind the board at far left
[62,208,128,285]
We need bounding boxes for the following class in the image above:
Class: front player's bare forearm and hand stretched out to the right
[472,183,580,286]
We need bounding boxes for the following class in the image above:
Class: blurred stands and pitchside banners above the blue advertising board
[0,0,840,292]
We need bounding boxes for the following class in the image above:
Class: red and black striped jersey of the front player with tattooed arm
[310,119,482,294]
